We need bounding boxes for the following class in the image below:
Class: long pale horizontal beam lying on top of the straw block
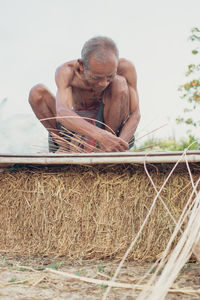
[0,151,200,167]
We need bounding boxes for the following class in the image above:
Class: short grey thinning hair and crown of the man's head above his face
[81,36,119,69]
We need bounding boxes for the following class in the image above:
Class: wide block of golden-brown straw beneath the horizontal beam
[0,164,200,261]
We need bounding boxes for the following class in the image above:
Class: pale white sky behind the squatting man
[0,0,200,142]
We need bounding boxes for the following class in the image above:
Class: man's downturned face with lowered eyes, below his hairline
[84,53,118,92]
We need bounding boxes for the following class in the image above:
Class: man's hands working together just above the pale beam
[98,130,129,152]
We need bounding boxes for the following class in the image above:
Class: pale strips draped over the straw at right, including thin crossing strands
[102,150,200,300]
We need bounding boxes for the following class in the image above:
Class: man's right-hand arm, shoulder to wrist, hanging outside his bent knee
[119,59,140,142]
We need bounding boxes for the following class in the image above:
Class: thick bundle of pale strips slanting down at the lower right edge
[138,150,200,300]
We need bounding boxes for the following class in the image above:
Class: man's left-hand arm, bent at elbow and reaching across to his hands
[56,65,128,152]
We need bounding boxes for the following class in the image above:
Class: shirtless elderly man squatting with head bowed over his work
[29,36,140,152]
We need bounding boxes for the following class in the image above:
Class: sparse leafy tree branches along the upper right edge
[176,27,200,127]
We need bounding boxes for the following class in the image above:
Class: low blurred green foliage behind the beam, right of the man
[133,135,199,152]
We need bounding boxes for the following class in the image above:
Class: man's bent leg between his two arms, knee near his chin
[103,76,130,134]
